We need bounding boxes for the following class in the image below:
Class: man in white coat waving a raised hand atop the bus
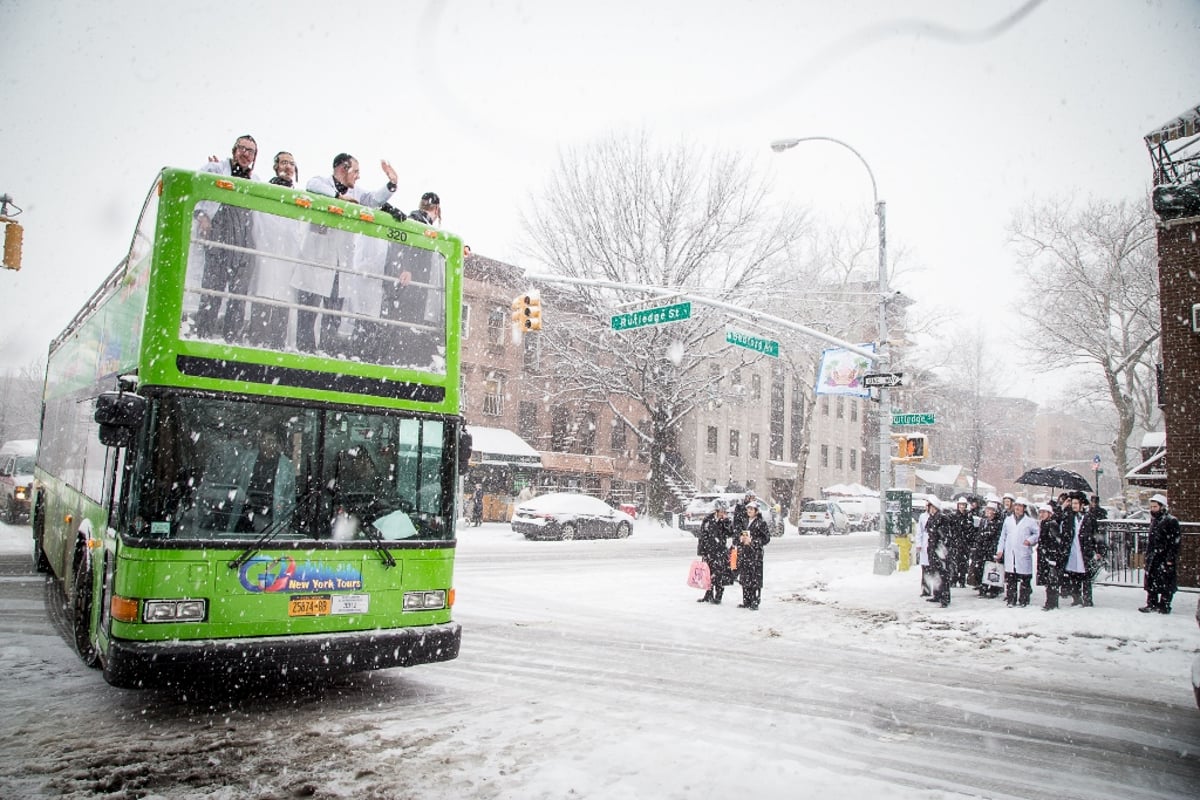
[292,152,396,353]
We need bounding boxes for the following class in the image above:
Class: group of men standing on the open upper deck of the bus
[193,134,442,359]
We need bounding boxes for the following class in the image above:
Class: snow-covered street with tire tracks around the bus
[0,522,1200,800]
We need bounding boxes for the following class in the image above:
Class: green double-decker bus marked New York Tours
[32,169,470,687]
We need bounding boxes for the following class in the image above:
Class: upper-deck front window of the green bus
[179,200,446,374]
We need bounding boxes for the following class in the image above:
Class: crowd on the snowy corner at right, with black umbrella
[914,492,1180,614]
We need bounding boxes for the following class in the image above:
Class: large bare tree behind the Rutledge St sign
[526,134,803,515]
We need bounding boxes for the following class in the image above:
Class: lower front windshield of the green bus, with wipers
[127,395,454,542]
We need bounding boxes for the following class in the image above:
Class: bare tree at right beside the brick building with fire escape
[1010,200,1159,492]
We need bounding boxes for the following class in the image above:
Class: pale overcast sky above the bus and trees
[0,0,1200,399]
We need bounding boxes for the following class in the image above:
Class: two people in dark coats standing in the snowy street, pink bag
[696,492,770,610]
